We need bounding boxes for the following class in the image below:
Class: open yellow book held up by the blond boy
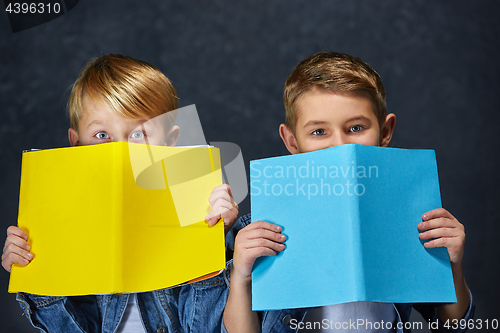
[9,142,225,296]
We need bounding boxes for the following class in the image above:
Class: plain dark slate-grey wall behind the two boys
[0,0,500,332]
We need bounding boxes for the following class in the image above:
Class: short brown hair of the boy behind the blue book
[283,52,387,133]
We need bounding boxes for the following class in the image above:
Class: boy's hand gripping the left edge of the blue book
[231,221,286,282]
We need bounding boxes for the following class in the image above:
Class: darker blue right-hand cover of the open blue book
[354,145,456,303]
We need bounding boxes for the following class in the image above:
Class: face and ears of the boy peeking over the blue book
[280,89,396,154]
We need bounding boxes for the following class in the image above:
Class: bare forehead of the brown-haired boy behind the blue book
[296,88,377,128]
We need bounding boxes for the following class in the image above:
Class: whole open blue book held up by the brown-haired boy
[250,144,456,311]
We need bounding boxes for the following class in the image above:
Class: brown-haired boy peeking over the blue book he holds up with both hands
[223,52,473,333]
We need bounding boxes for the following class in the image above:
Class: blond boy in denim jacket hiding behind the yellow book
[2,55,238,333]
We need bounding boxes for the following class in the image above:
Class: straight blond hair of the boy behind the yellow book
[68,54,178,130]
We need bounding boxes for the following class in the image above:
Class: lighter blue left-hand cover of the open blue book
[250,150,364,310]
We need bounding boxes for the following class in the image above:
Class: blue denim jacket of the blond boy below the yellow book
[17,270,229,333]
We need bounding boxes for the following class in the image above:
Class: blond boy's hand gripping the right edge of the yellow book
[205,184,239,234]
